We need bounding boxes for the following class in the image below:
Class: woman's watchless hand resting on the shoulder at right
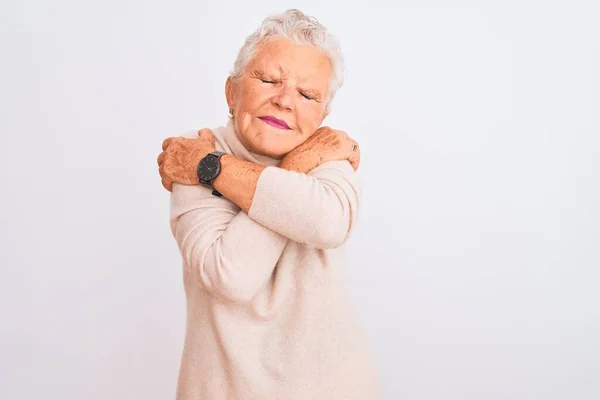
[279,126,360,173]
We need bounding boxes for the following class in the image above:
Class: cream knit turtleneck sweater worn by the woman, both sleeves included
[171,122,379,400]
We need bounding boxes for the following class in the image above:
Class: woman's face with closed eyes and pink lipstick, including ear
[226,39,332,159]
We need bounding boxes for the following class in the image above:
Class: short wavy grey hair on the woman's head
[231,9,346,112]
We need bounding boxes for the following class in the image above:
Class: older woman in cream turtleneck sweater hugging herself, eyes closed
[158,10,378,400]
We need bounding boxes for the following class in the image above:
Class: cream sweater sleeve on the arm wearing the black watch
[248,161,360,249]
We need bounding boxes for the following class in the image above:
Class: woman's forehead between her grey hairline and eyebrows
[248,38,332,83]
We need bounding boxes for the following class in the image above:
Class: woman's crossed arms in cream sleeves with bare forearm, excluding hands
[171,156,360,303]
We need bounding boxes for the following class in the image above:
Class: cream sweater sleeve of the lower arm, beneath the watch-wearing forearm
[171,184,287,303]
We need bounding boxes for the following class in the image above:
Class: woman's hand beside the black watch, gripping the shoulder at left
[156,129,216,192]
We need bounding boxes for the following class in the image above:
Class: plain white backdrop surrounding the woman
[0,0,600,400]
